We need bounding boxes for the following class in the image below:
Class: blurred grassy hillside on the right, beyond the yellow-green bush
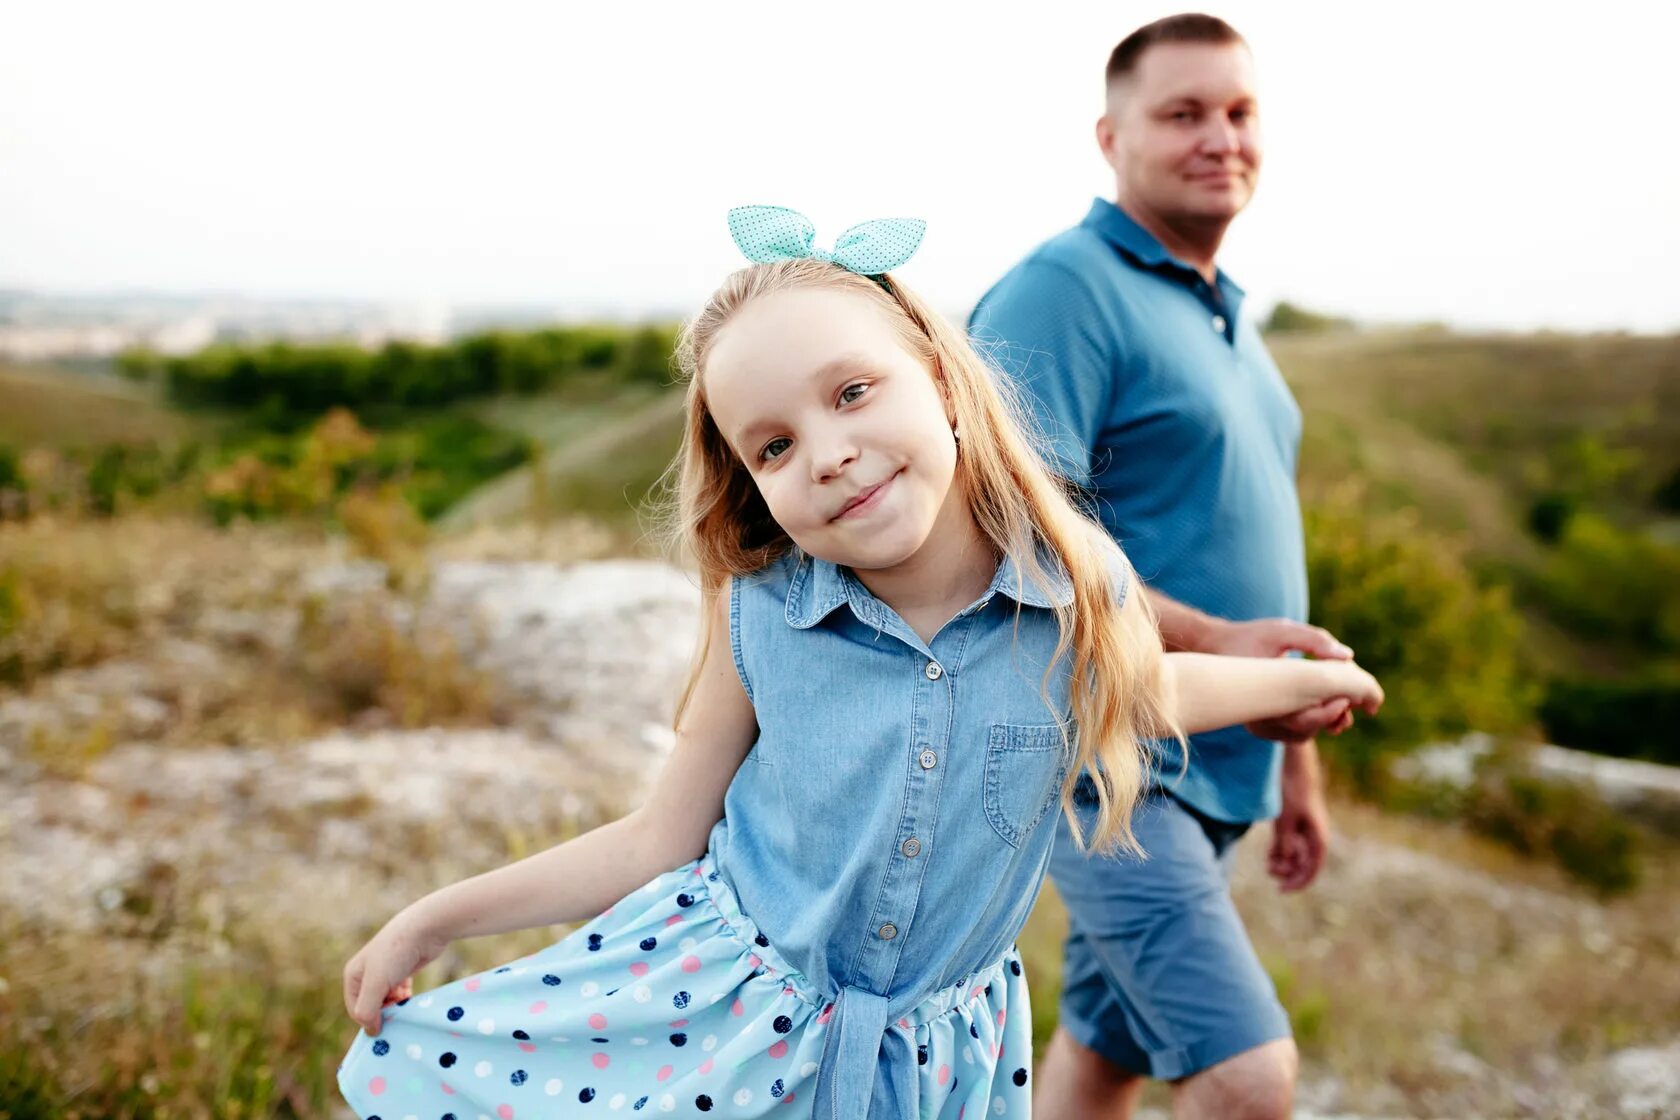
[1270,331,1680,672]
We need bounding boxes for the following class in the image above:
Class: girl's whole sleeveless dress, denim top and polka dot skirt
[339,552,1126,1120]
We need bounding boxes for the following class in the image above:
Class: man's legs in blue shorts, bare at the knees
[1035,791,1295,1117]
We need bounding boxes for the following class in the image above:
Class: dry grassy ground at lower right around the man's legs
[1021,803,1680,1117]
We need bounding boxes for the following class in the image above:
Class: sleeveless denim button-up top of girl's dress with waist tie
[709,551,1124,1120]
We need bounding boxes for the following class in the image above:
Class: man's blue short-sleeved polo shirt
[968,198,1307,821]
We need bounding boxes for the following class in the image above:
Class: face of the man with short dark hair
[1097,44,1260,222]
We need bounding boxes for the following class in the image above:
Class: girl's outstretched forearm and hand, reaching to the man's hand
[1161,653,1383,735]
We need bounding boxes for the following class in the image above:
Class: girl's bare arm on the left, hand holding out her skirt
[344,588,758,1034]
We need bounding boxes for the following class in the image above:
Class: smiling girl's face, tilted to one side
[702,289,968,569]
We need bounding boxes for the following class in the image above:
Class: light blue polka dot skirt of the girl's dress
[338,855,1032,1120]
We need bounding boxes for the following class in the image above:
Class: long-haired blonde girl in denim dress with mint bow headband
[339,207,1383,1120]
